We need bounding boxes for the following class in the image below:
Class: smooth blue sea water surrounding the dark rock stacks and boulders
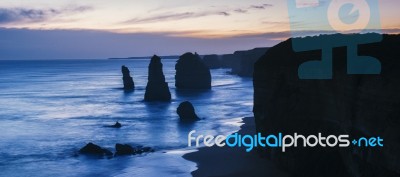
[0,60,253,176]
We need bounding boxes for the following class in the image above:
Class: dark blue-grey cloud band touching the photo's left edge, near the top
[0,6,91,24]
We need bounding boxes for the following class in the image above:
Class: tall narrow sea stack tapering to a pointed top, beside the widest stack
[144,55,171,101]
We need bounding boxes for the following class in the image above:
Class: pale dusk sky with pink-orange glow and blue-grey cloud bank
[0,0,400,59]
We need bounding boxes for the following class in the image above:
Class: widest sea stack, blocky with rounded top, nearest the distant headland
[175,52,211,89]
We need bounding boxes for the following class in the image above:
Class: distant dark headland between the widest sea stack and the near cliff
[203,47,268,77]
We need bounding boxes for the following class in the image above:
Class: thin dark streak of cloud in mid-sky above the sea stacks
[123,11,230,23]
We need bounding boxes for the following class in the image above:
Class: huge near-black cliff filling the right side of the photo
[253,35,400,176]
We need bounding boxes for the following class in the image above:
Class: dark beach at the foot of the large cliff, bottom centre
[183,117,289,177]
